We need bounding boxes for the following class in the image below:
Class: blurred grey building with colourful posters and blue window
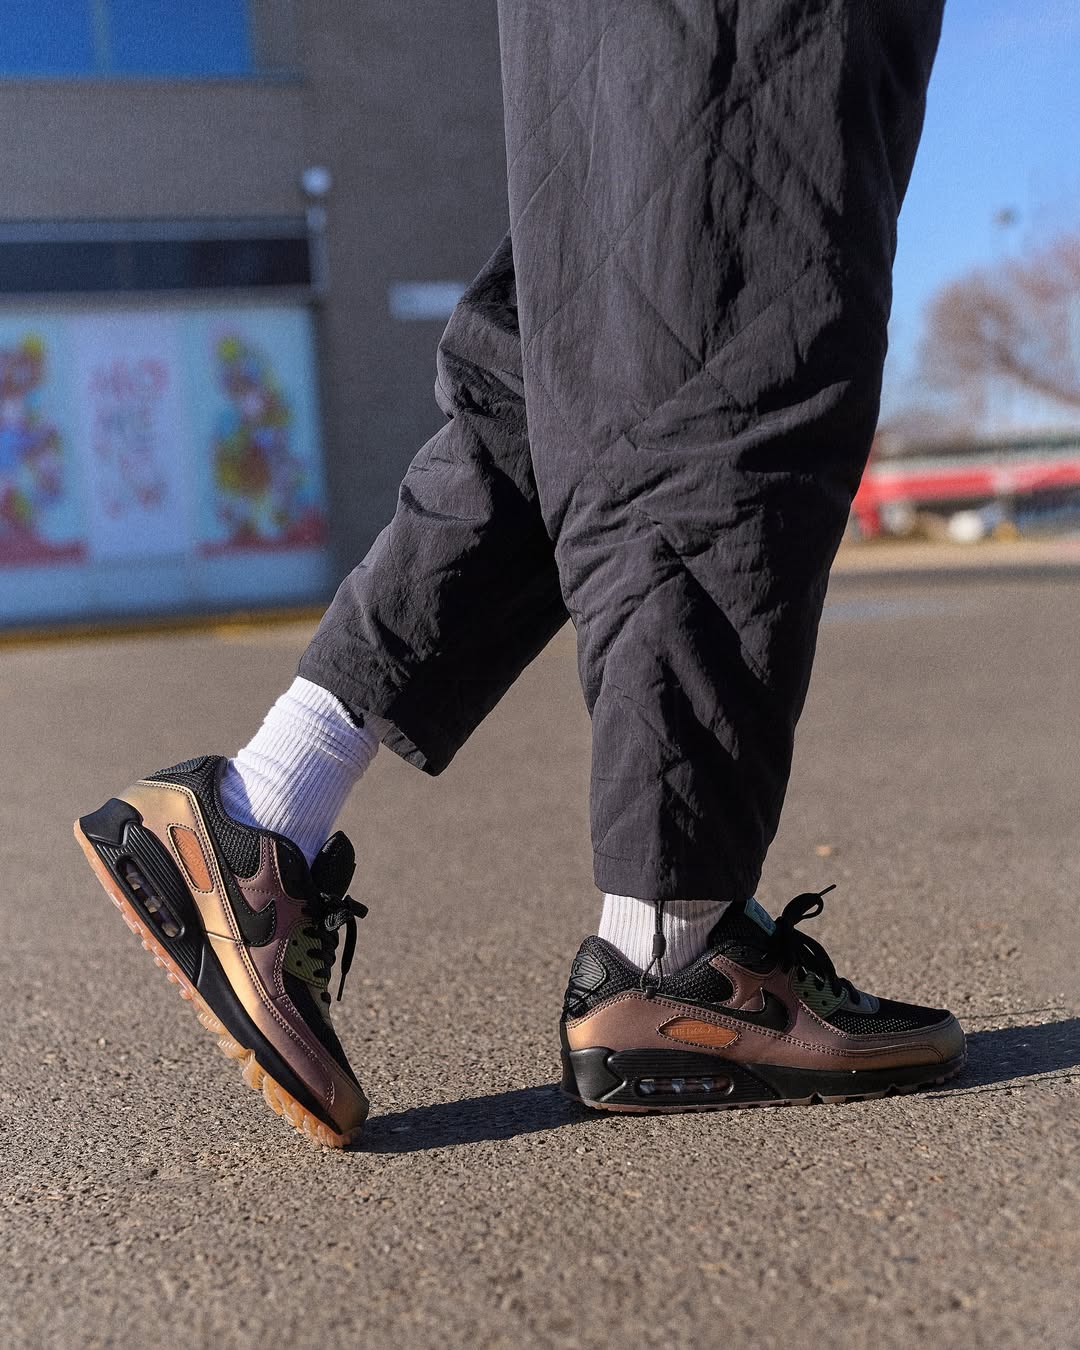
[0,0,506,625]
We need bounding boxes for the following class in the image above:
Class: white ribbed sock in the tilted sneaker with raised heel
[221,676,386,863]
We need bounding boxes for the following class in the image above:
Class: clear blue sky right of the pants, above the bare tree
[884,0,1080,412]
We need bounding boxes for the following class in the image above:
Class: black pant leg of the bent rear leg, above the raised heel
[300,236,567,774]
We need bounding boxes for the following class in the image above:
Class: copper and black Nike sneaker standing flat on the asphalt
[560,887,964,1111]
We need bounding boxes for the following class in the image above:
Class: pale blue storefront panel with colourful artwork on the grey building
[0,305,327,622]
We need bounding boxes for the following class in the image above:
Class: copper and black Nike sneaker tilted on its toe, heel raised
[76,755,367,1148]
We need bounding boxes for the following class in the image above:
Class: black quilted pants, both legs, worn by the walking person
[301,0,942,899]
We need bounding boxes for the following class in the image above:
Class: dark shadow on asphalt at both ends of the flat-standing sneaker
[356,1018,1080,1153]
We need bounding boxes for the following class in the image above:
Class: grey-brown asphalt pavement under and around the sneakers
[0,575,1080,1350]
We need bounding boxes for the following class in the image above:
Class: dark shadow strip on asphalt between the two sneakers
[358,1083,585,1153]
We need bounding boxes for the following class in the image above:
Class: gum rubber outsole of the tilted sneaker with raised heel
[74,821,363,1149]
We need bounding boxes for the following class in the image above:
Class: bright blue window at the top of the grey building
[0,0,296,78]
